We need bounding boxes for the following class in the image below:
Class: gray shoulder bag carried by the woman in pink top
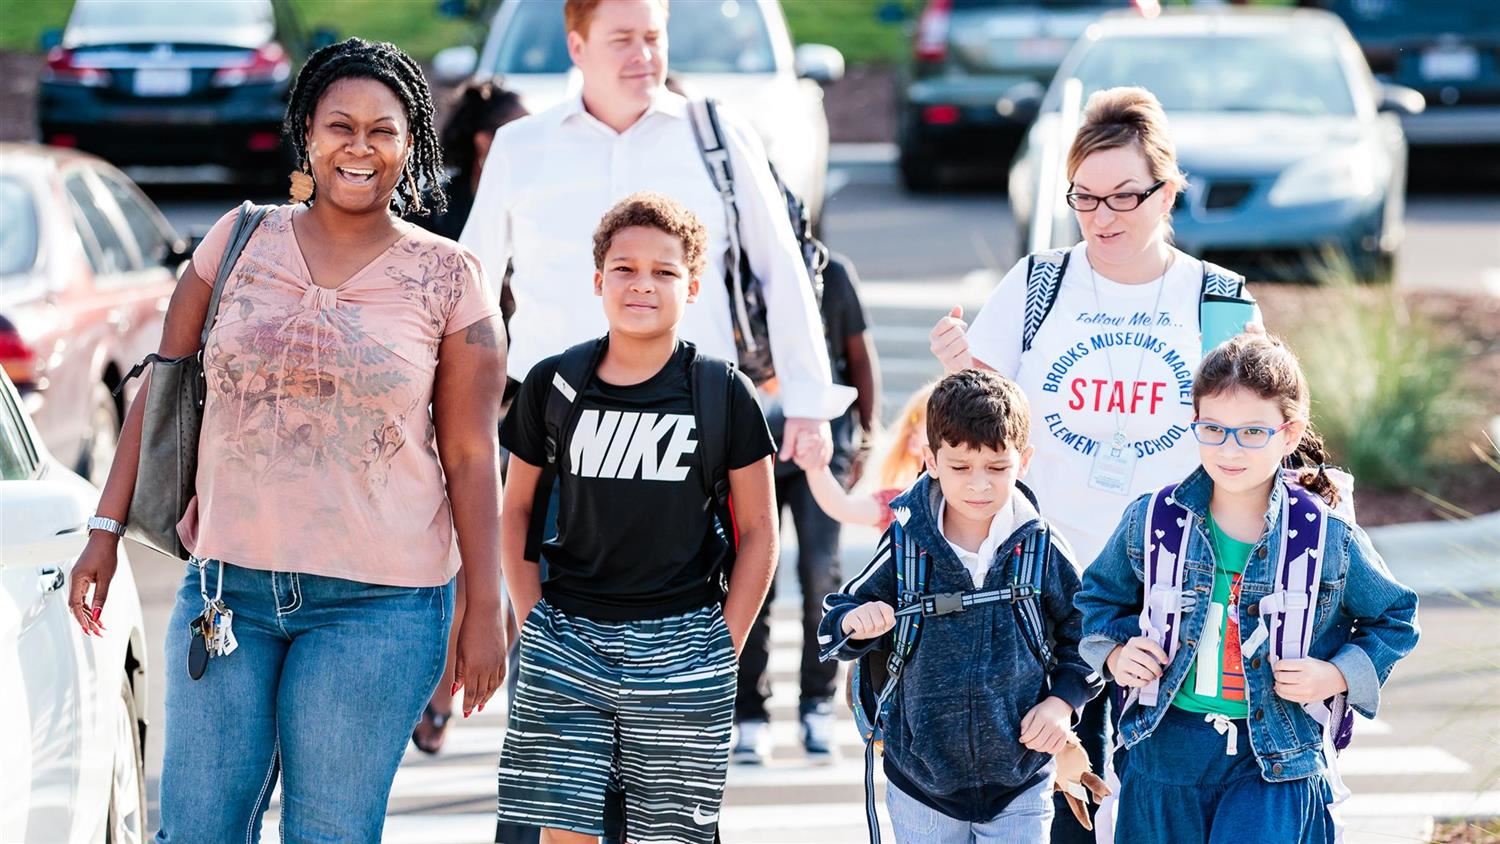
[116,202,270,559]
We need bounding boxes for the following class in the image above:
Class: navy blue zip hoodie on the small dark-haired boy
[818,475,1103,823]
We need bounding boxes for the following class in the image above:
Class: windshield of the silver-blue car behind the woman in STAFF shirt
[1049,33,1355,115]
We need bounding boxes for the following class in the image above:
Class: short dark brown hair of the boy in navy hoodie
[927,369,1031,453]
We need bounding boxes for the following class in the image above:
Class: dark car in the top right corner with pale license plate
[1304,0,1500,156]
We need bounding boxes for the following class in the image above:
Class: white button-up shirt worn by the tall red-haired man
[459,88,855,418]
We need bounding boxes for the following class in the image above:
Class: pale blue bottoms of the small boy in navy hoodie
[885,777,1053,844]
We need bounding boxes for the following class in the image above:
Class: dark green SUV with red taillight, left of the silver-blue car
[897,0,1157,190]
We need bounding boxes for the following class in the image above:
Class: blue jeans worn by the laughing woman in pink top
[156,561,453,844]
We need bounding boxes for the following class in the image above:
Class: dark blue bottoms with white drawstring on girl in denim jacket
[1115,706,1334,844]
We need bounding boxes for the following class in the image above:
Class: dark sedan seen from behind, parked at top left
[38,0,333,178]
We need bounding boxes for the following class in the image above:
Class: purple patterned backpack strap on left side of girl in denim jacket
[1139,484,1196,706]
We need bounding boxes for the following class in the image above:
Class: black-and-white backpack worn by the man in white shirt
[689,99,828,385]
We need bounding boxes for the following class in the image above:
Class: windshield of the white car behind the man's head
[494,0,776,75]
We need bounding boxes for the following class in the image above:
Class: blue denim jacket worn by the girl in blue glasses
[1077,468,1419,781]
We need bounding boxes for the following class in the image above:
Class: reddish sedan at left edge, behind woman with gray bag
[0,144,188,484]
